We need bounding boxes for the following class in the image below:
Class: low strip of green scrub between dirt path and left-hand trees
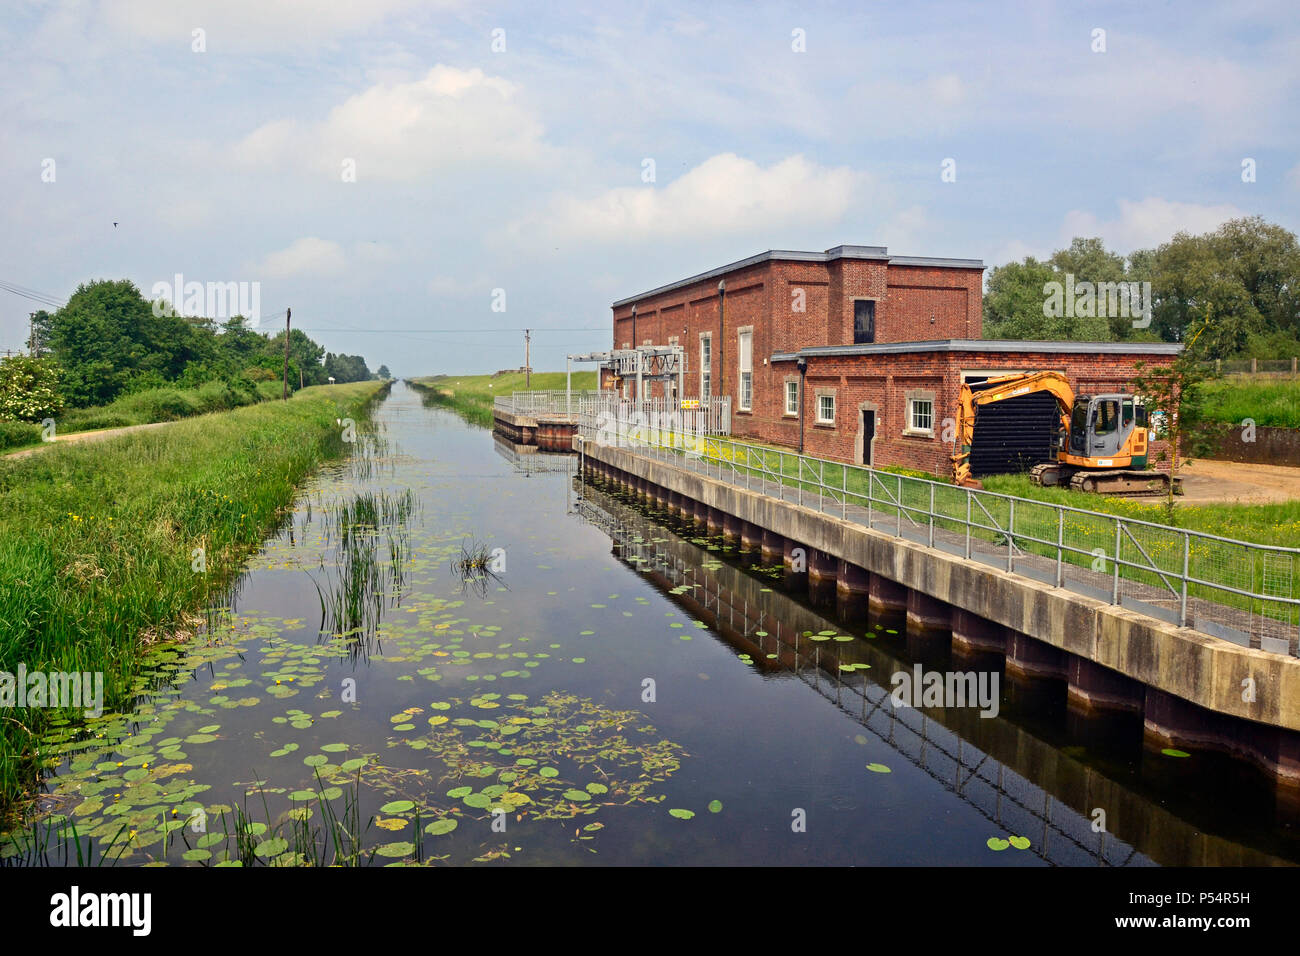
[0,381,282,451]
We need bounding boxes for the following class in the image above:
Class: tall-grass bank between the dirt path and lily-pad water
[0,381,386,809]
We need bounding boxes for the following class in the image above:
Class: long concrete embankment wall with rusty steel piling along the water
[584,442,1300,787]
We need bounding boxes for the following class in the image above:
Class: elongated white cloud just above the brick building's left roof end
[511,152,866,242]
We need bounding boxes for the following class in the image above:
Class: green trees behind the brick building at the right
[984,216,1300,359]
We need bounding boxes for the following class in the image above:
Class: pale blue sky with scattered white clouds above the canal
[0,0,1300,377]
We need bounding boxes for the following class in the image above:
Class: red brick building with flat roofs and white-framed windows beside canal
[614,246,1179,473]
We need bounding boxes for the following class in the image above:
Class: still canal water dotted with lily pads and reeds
[0,384,1300,866]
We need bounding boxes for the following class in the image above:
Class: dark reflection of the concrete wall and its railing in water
[577,475,1287,866]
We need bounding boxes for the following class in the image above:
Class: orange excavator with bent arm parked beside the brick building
[953,372,1180,496]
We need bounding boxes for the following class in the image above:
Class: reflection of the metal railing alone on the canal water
[577,497,1152,866]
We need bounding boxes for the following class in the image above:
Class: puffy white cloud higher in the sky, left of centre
[234,64,549,182]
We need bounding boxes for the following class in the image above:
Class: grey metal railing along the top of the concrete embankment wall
[579,416,1300,654]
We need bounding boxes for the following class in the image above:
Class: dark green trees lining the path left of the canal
[0,280,387,420]
